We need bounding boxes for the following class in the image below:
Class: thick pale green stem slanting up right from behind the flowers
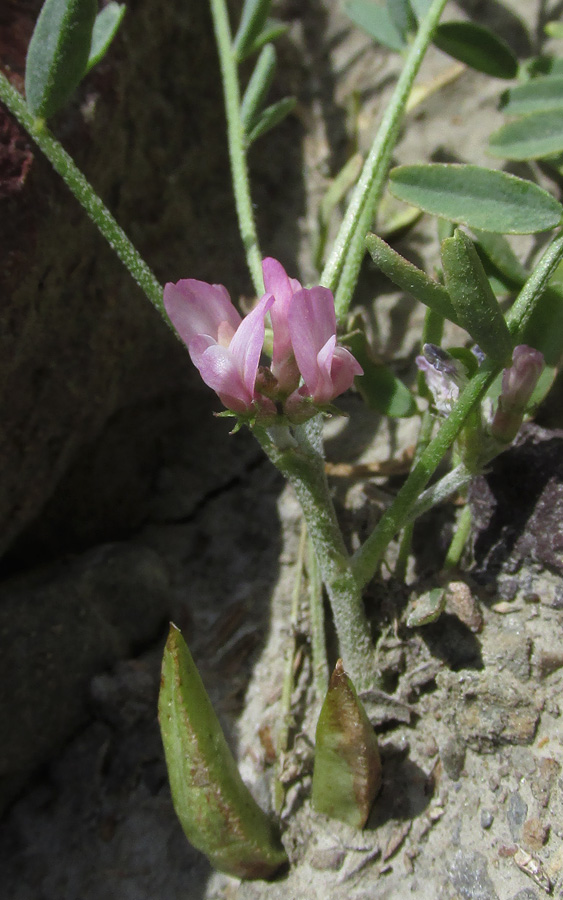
[321,0,447,320]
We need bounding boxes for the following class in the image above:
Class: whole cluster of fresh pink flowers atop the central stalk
[164,258,362,422]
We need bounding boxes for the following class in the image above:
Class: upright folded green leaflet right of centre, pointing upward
[442,228,512,365]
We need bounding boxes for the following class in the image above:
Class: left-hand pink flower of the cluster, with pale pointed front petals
[164,278,275,415]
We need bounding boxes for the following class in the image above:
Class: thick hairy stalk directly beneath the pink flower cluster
[254,423,376,690]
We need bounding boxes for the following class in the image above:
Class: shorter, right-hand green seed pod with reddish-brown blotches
[313,659,381,828]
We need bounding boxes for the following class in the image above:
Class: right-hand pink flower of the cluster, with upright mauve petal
[287,287,363,406]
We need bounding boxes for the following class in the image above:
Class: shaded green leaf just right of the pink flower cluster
[344,331,417,419]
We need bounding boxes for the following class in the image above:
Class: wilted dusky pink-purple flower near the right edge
[490,344,544,443]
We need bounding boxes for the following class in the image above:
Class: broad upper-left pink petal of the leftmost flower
[163,278,241,345]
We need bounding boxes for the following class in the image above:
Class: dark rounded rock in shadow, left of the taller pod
[0,543,169,806]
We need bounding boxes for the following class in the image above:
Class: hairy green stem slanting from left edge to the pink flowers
[0,72,165,316]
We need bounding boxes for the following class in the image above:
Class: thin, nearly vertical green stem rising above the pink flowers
[211,0,264,296]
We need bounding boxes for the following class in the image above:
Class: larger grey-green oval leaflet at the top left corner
[25,0,98,119]
